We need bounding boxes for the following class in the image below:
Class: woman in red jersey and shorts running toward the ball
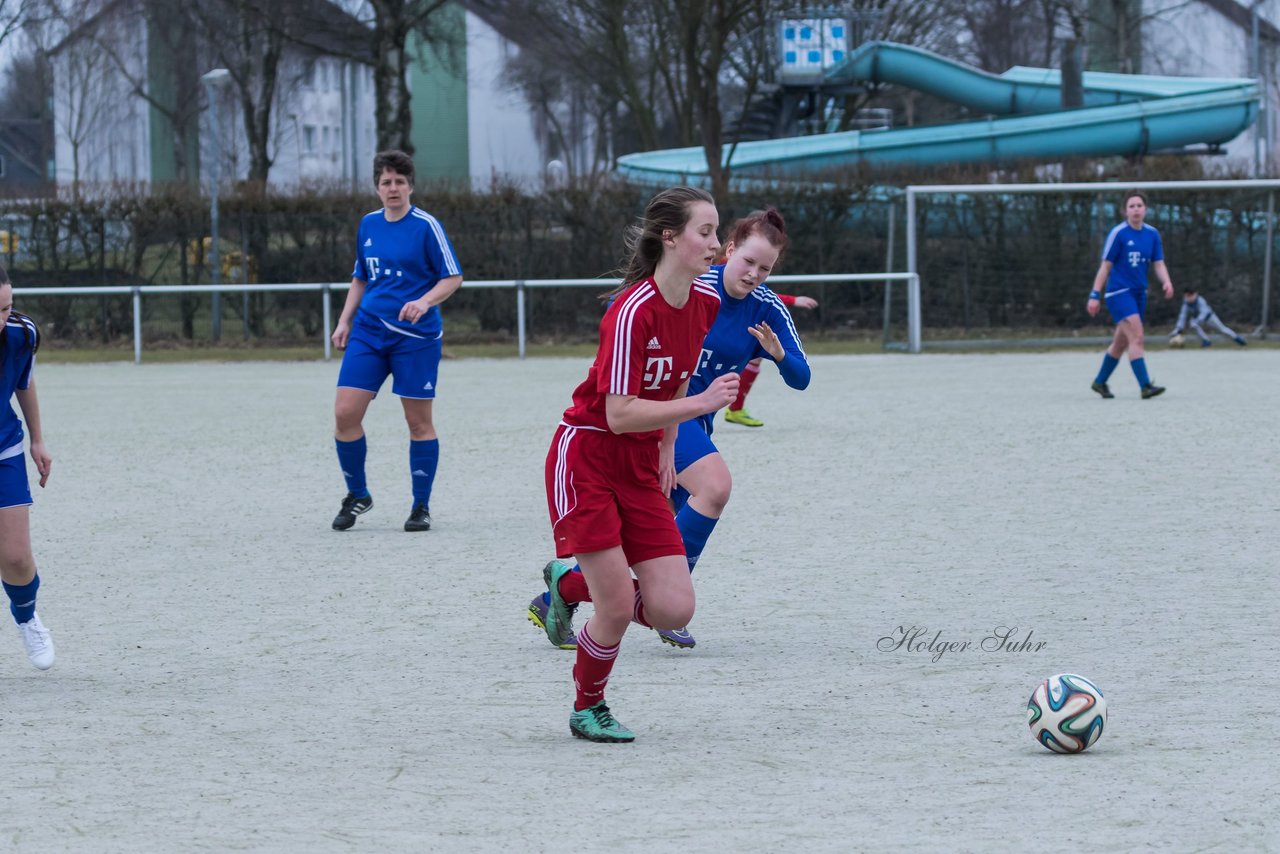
[544,187,737,741]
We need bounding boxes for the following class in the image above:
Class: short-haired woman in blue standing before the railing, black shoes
[333,151,462,531]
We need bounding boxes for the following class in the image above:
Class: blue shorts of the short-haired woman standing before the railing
[338,318,443,401]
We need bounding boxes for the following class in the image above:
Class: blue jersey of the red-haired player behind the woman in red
[689,264,810,433]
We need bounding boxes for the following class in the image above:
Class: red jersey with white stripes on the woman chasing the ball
[564,279,719,442]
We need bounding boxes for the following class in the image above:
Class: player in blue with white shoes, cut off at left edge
[0,268,54,670]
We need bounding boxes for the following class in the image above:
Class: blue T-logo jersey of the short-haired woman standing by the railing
[351,205,462,338]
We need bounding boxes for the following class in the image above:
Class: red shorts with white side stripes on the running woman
[547,424,685,566]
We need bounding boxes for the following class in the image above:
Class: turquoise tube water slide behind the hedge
[617,41,1260,184]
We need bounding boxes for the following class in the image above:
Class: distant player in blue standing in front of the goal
[1087,192,1174,399]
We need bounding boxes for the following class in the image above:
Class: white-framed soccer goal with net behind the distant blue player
[904,179,1280,348]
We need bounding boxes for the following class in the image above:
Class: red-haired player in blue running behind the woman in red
[529,207,810,649]
